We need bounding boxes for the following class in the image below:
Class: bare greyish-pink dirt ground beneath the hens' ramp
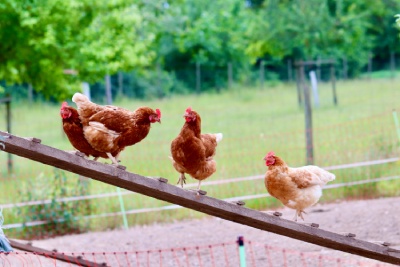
[7,197,390,266]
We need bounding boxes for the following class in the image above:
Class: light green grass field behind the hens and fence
[0,80,400,239]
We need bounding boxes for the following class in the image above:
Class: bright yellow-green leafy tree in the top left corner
[0,0,154,99]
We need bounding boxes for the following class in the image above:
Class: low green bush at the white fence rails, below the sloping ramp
[18,169,90,239]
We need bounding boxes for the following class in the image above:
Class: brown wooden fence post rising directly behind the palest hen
[300,64,314,165]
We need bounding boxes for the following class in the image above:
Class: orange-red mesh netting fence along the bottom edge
[0,241,394,267]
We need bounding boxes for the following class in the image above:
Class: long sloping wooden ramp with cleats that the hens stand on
[0,131,400,264]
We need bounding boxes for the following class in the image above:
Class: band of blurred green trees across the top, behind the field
[0,0,400,101]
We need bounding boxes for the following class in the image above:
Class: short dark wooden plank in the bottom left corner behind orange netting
[9,239,109,267]
